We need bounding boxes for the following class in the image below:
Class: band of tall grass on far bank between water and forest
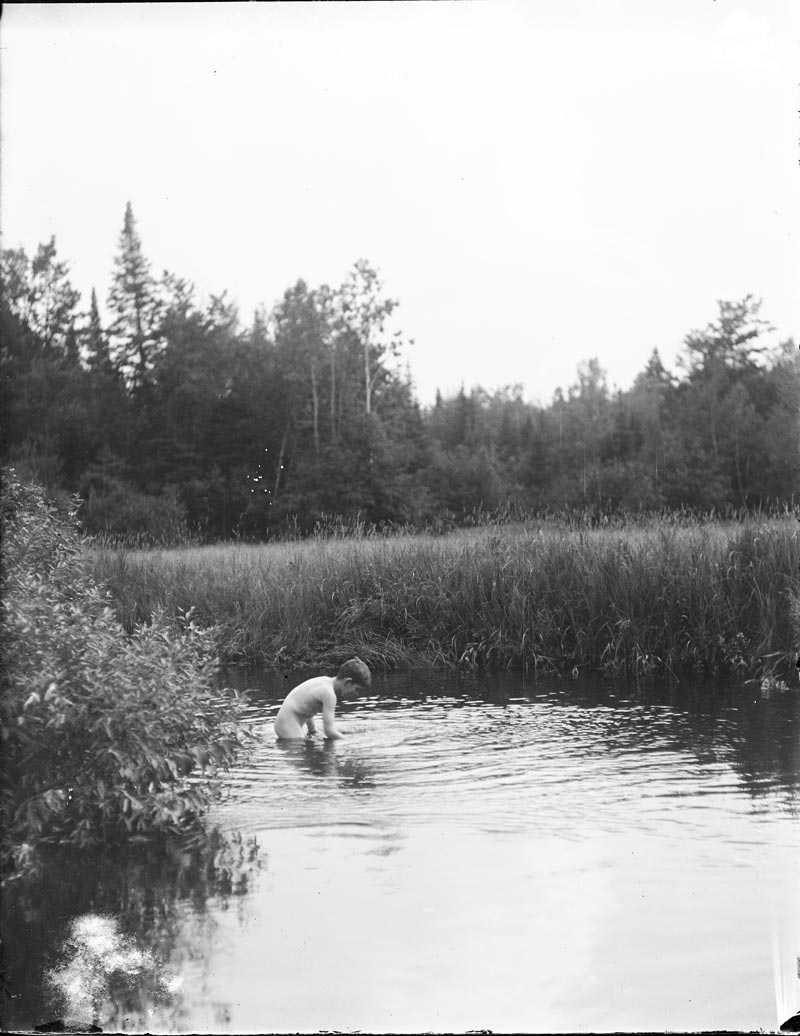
[84,517,800,677]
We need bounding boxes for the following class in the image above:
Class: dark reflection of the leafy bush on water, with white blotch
[2,831,261,1031]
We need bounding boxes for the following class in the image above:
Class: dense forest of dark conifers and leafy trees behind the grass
[0,204,800,542]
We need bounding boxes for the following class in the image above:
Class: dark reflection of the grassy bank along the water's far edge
[224,669,800,809]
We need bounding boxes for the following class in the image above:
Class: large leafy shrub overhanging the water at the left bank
[0,471,245,866]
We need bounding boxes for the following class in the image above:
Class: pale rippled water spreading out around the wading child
[214,696,798,837]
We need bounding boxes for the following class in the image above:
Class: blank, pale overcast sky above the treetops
[0,0,800,405]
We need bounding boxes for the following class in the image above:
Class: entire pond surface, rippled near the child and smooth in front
[3,673,800,1033]
